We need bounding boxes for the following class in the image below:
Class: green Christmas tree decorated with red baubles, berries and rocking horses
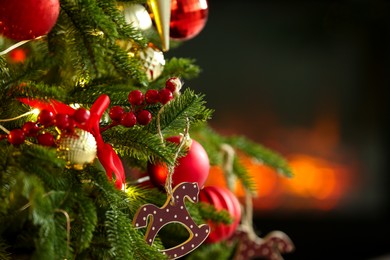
[0,0,292,259]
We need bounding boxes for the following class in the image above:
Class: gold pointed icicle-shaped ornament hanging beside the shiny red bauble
[147,0,171,51]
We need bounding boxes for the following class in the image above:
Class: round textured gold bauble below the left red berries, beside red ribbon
[57,129,97,170]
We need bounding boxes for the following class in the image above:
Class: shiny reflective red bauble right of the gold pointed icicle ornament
[169,0,209,40]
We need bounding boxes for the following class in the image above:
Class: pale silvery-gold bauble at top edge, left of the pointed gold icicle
[123,4,152,30]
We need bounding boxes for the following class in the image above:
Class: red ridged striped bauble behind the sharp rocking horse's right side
[199,186,241,243]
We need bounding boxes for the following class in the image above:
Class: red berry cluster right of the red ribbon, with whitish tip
[109,77,181,127]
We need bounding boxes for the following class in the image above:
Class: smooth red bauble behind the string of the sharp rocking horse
[148,136,210,187]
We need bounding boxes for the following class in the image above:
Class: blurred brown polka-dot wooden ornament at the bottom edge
[230,228,294,260]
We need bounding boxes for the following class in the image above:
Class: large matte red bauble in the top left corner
[0,0,60,40]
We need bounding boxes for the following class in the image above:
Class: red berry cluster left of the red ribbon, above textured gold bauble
[4,108,90,146]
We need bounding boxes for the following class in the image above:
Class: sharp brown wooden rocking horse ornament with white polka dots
[133,182,210,259]
